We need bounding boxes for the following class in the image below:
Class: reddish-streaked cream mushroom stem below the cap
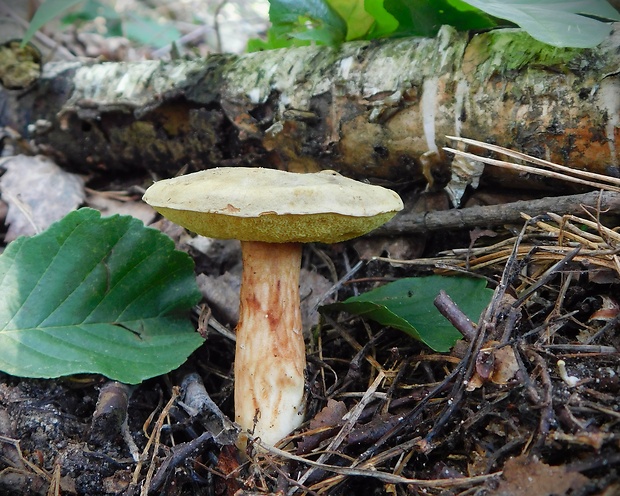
[235,241,306,445]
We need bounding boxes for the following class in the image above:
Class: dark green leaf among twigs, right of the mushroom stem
[323,276,493,352]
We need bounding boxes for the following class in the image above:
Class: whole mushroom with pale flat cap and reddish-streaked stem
[143,167,403,445]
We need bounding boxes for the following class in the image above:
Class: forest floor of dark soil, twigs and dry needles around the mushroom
[0,1,620,496]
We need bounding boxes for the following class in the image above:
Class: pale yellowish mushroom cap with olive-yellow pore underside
[143,167,403,243]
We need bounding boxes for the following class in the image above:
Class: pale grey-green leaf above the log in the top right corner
[467,0,620,48]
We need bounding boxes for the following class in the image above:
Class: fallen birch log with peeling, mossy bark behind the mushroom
[0,24,620,188]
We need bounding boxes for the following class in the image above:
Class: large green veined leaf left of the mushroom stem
[0,208,202,384]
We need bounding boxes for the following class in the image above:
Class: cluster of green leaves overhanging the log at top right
[248,0,620,51]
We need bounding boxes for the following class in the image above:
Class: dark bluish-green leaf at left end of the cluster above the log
[269,0,347,45]
